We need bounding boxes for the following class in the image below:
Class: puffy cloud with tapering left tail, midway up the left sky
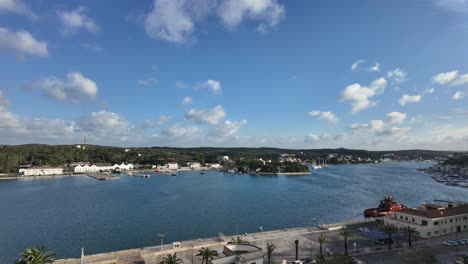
[31,72,98,103]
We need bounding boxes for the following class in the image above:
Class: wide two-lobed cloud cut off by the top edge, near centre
[144,0,285,44]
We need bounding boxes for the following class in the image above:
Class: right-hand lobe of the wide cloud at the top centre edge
[218,0,285,32]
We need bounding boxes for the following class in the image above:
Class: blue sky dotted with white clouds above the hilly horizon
[0,0,468,150]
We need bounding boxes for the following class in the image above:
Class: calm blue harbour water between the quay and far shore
[0,163,468,263]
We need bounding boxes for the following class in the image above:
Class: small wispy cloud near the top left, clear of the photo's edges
[57,6,99,35]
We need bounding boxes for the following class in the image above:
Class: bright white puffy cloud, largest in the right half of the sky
[339,78,387,113]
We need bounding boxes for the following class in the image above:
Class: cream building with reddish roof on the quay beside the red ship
[384,203,468,238]
